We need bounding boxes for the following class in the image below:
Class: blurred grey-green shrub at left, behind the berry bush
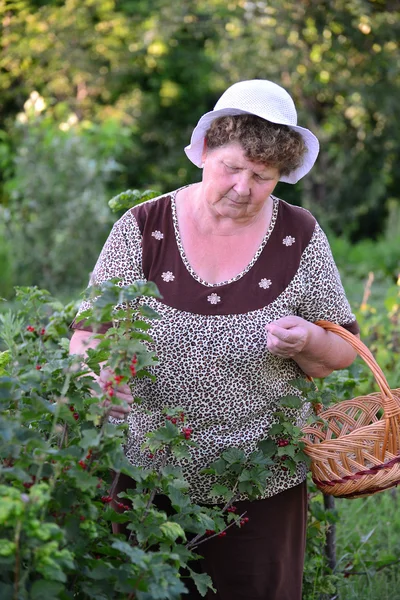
[4,110,132,294]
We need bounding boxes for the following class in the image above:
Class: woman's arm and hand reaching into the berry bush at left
[69,329,133,419]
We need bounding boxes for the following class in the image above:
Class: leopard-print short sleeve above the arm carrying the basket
[298,223,359,334]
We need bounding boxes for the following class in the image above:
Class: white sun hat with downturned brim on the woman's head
[185,79,319,183]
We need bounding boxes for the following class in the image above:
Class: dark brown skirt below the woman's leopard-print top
[114,476,307,600]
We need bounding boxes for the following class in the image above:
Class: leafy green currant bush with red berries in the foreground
[0,282,320,600]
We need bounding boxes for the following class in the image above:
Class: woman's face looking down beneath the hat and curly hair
[201,142,280,220]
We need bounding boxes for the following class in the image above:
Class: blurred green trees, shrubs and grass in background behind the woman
[0,0,400,600]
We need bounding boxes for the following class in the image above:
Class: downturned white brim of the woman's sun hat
[185,108,319,183]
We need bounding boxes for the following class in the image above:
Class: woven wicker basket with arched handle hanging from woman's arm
[303,321,400,498]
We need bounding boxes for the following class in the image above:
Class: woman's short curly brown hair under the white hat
[206,114,307,175]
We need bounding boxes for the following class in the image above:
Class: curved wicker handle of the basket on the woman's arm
[314,320,399,410]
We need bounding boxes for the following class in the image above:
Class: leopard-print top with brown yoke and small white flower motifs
[73,191,358,503]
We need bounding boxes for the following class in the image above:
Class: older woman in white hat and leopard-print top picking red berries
[71,80,358,600]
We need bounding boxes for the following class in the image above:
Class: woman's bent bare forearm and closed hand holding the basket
[266,316,357,377]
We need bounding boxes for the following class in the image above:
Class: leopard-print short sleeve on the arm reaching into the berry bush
[71,211,145,332]
